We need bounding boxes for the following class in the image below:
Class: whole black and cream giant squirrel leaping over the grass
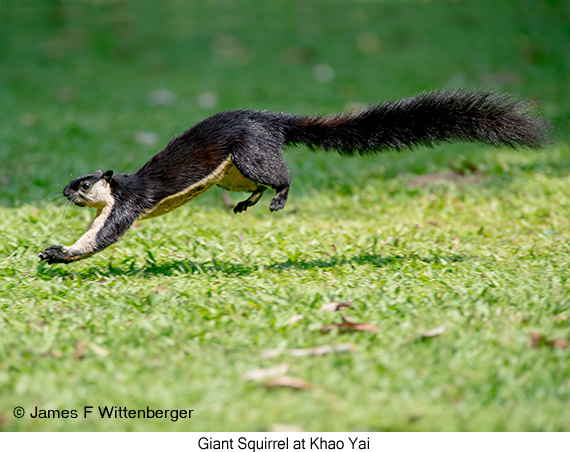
[38,90,549,264]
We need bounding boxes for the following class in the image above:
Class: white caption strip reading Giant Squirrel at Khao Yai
[0,432,570,452]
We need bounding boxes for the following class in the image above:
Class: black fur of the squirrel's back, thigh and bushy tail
[118,91,548,210]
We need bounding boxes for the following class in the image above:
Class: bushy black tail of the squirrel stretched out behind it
[286,90,549,155]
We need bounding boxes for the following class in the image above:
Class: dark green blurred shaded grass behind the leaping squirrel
[0,0,570,206]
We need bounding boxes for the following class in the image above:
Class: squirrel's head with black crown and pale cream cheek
[63,170,115,209]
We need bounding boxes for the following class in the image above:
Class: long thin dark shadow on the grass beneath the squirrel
[37,253,466,280]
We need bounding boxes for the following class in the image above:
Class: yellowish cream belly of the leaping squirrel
[139,157,257,220]
